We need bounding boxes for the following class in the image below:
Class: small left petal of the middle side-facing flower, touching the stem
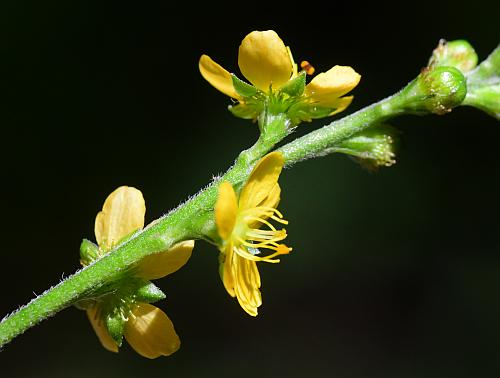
[215,181,238,240]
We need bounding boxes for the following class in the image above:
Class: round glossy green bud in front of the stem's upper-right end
[402,66,467,114]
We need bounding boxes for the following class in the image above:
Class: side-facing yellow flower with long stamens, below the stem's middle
[215,152,292,316]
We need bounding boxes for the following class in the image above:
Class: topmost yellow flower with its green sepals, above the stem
[199,30,360,123]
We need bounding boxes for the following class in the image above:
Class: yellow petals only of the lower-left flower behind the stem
[87,186,194,358]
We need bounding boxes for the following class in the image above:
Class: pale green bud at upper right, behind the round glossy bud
[429,39,477,73]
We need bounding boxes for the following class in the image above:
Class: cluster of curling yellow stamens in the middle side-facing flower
[233,206,292,263]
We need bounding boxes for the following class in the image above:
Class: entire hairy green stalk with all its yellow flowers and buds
[0,30,500,358]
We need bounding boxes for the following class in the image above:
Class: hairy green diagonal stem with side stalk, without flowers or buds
[0,68,464,347]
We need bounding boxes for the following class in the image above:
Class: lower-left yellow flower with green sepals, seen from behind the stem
[82,186,194,358]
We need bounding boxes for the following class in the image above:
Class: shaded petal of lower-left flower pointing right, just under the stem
[137,240,194,280]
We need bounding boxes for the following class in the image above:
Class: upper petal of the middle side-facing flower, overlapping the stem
[239,151,285,211]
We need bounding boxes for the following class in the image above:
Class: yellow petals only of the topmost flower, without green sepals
[199,30,361,114]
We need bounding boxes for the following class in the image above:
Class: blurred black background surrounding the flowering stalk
[0,1,500,378]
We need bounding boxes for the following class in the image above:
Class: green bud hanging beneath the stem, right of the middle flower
[336,125,398,170]
